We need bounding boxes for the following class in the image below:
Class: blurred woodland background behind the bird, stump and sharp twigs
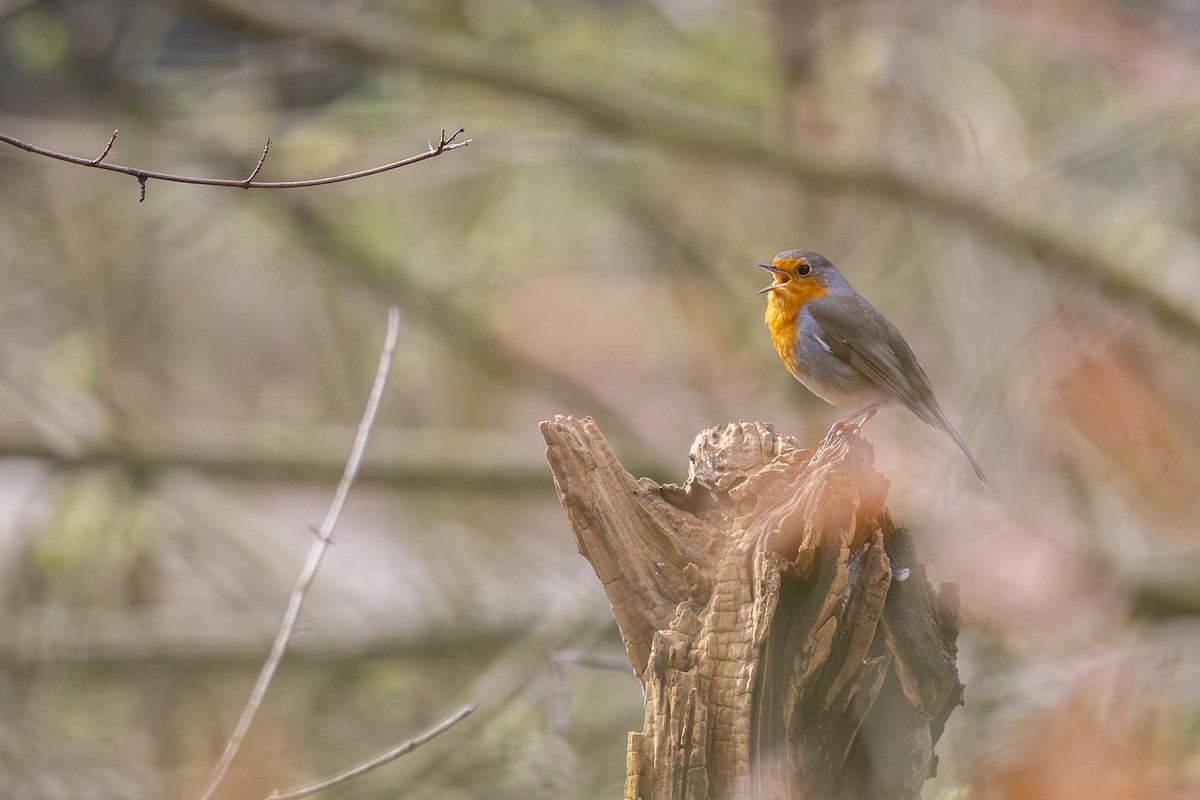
[0,0,1200,800]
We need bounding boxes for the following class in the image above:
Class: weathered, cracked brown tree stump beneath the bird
[541,416,962,800]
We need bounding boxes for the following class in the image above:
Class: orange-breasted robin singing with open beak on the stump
[757,249,988,487]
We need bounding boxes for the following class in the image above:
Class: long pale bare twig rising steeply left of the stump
[200,306,400,800]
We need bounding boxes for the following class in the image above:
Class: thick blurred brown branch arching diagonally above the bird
[184,0,1200,342]
